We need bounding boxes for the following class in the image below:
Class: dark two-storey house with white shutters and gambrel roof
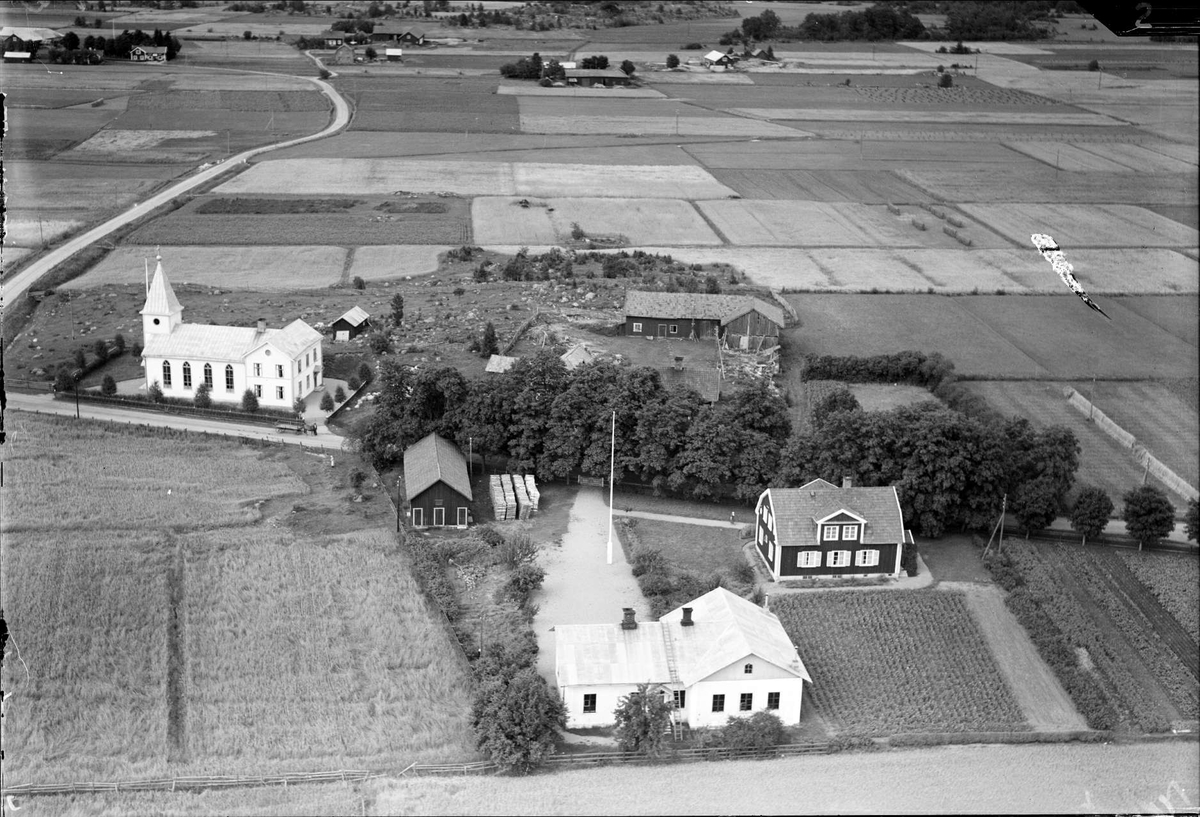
[755,480,913,582]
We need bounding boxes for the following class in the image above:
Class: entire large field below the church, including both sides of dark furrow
[2,415,473,783]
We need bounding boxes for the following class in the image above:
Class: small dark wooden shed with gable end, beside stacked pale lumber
[404,434,472,528]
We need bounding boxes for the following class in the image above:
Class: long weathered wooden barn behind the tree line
[625,289,785,349]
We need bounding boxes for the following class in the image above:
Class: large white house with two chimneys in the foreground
[554,588,812,728]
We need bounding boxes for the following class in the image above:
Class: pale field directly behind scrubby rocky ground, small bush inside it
[472,197,721,245]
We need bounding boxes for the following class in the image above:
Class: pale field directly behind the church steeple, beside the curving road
[64,245,347,292]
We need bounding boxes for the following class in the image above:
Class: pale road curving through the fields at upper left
[0,62,350,307]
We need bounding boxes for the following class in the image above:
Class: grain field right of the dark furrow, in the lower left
[182,529,472,769]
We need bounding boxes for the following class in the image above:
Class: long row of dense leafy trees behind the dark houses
[349,352,1079,536]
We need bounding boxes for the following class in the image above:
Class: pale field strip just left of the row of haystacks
[696,199,925,247]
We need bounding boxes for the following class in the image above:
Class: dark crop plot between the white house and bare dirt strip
[772,590,1027,735]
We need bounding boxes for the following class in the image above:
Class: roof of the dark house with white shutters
[767,480,905,547]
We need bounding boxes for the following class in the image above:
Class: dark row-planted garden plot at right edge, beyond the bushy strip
[1006,540,1200,732]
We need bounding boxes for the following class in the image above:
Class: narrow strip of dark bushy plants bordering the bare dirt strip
[984,553,1118,731]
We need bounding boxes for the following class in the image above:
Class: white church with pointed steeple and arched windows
[142,258,324,409]
